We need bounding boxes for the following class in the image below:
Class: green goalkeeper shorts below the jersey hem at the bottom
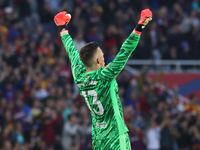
[92,133,131,150]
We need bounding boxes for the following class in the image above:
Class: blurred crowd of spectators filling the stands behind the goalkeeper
[0,0,200,150]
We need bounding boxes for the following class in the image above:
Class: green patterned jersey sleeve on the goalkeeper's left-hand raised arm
[61,33,86,82]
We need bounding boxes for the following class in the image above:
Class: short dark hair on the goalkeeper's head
[79,42,99,67]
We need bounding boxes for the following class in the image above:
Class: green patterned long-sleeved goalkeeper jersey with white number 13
[61,33,140,140]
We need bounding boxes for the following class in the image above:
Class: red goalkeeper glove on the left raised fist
[54,11,71,31]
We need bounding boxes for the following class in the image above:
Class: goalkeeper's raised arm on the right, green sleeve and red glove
[100,9,152,80]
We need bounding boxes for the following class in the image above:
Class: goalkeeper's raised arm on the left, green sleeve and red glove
[54,11,86,82]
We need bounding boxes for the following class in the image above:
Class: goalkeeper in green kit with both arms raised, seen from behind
[54,9,152,150]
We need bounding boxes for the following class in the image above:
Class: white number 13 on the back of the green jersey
[81,90,104,116]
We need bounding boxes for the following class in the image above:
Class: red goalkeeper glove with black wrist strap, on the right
[134,9,153,34]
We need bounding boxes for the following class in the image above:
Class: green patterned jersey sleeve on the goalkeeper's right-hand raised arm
[100,32,140,80]
